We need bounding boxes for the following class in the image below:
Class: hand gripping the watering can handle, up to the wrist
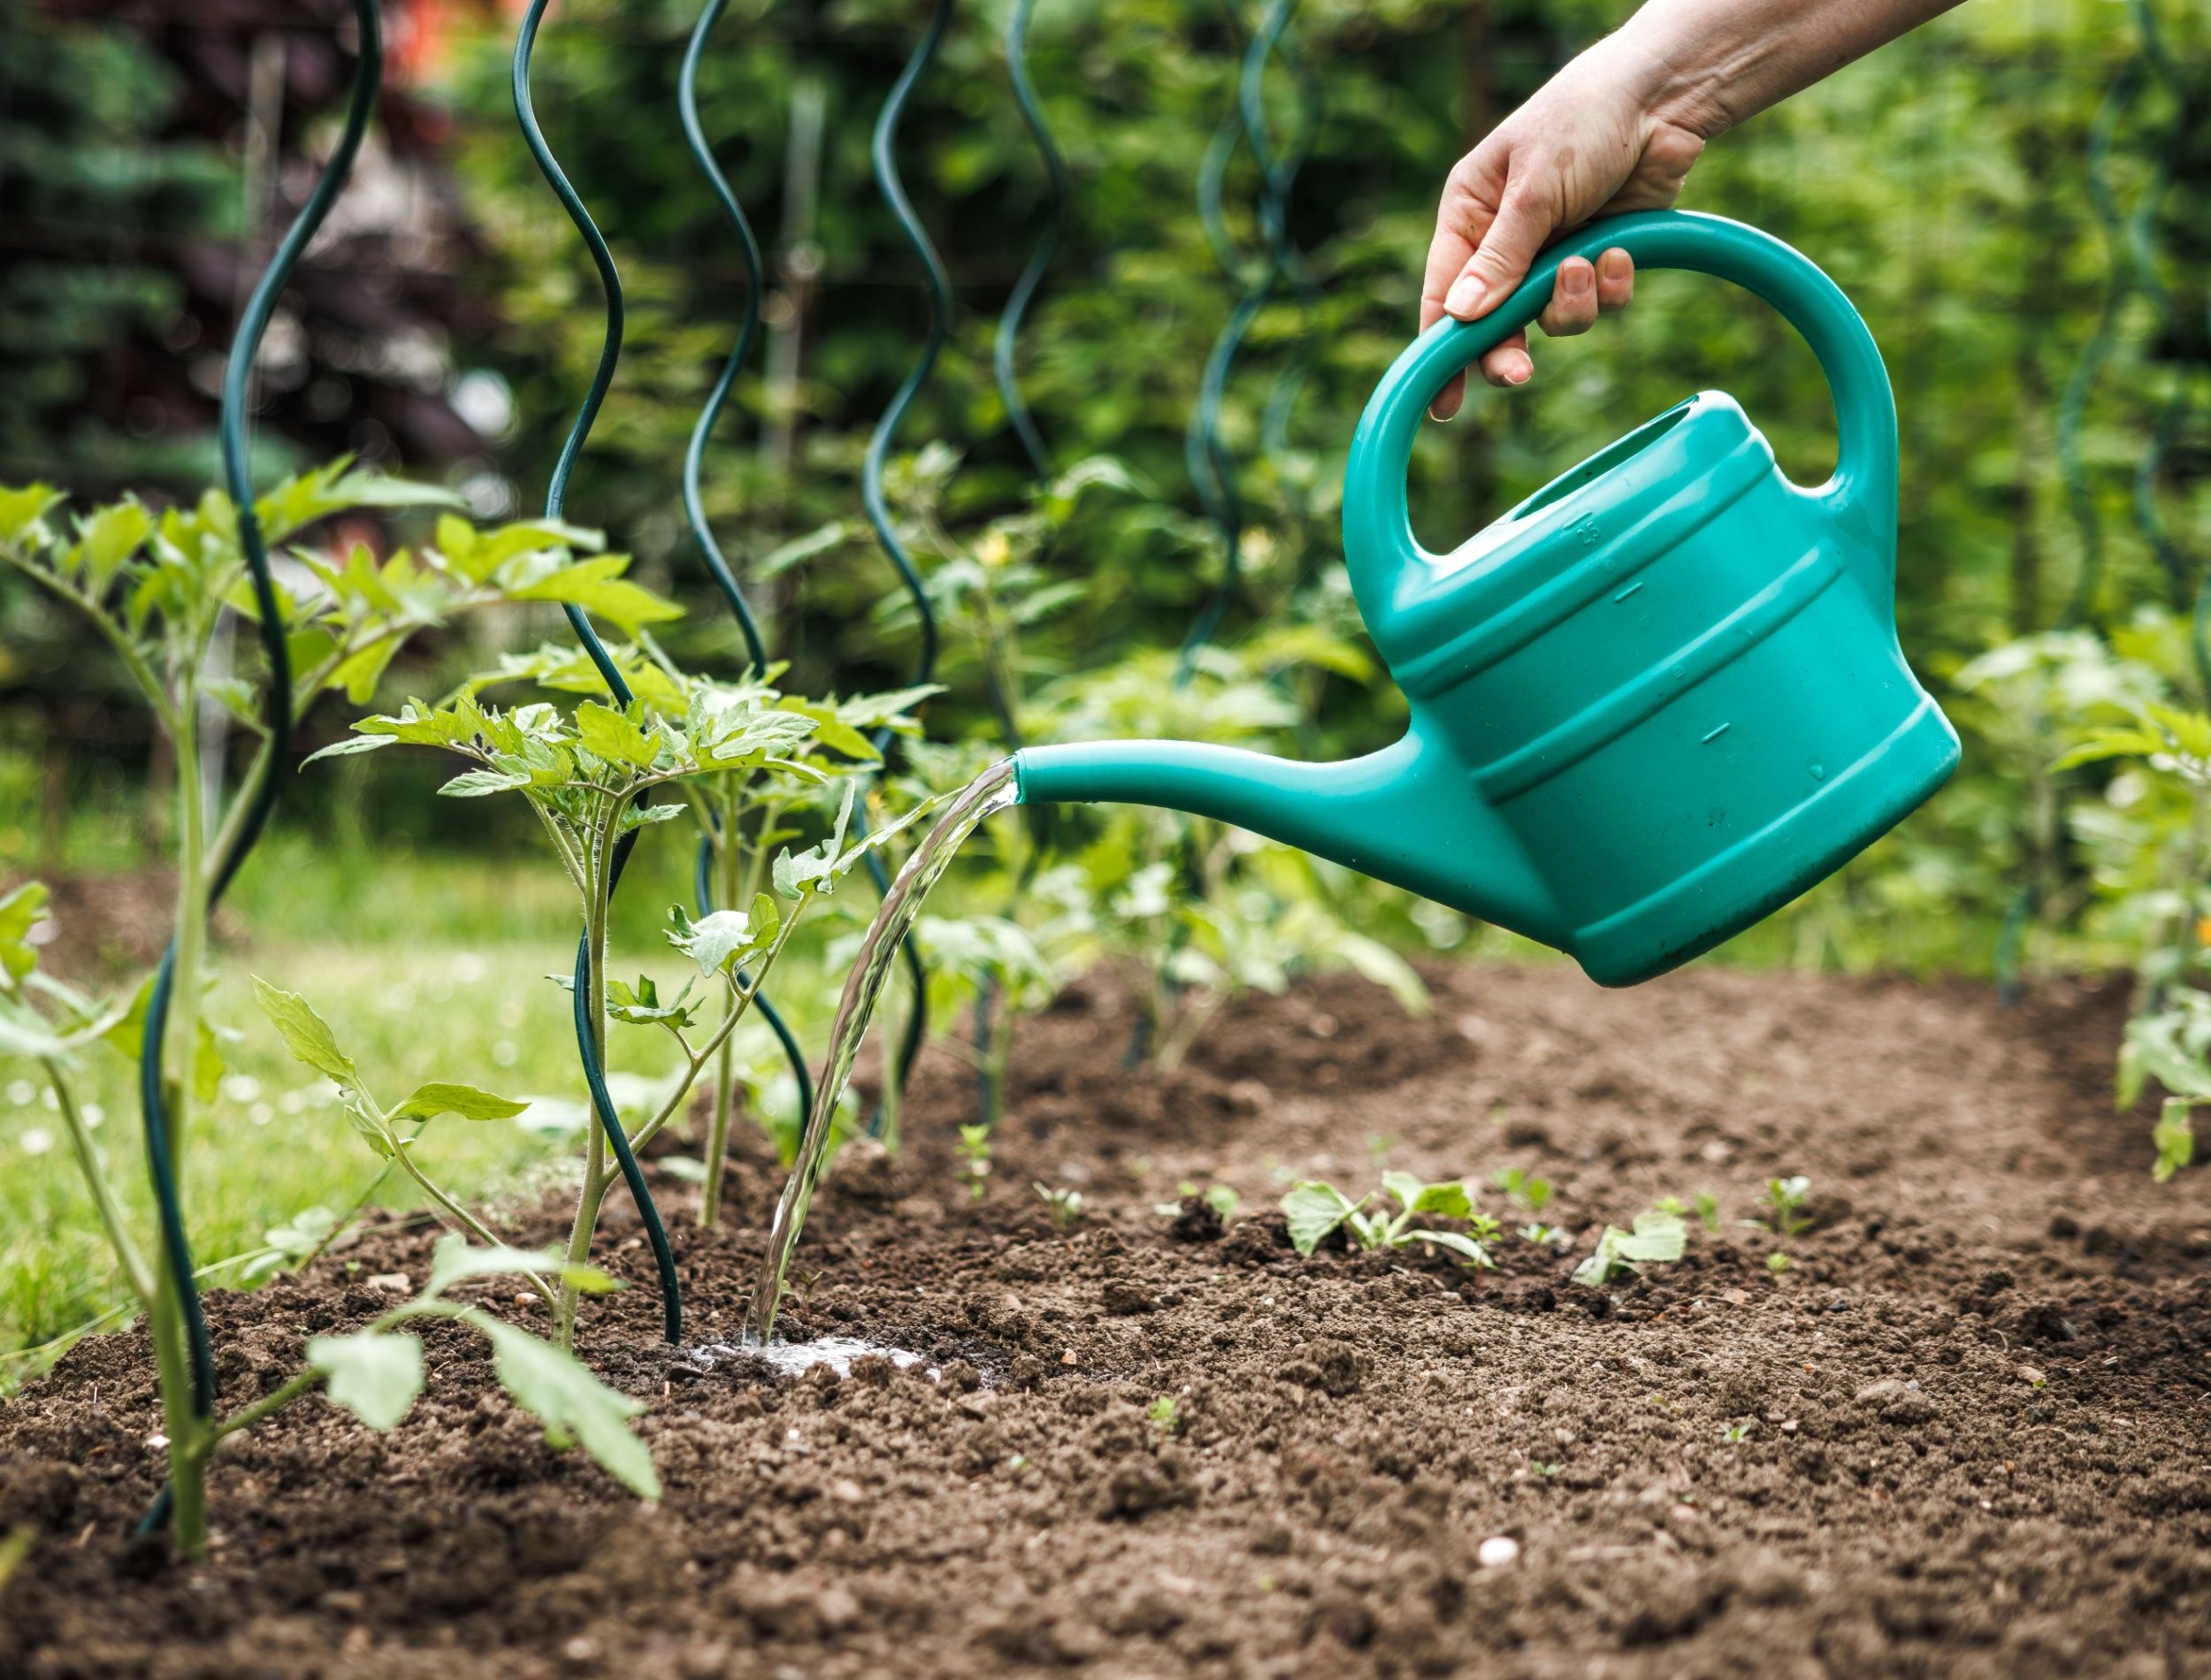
[1419,40,1705,420]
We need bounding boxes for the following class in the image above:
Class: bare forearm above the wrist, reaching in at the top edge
[1592,0,1959,140]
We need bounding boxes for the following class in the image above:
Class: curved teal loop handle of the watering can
[1344,210,1897,606]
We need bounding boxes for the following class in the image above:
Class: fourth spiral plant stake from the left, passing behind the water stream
[853,0,953,1132]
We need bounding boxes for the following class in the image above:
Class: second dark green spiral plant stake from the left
[513,0,684,1342]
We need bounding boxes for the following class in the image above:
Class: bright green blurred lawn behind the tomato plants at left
[0,836,853,1391]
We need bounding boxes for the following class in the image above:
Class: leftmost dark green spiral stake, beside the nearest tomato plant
[140,0,385,1534]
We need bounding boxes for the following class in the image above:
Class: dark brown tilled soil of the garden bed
[0,968,2211,1680]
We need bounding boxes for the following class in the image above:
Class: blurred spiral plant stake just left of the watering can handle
[1176,0,1304,681]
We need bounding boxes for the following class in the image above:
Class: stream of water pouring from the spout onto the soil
[746,759,1021,1347]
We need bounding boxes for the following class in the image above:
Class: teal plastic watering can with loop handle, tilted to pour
[1015,212,1959,986]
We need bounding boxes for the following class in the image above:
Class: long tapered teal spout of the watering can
[1013,732,1565,944]
